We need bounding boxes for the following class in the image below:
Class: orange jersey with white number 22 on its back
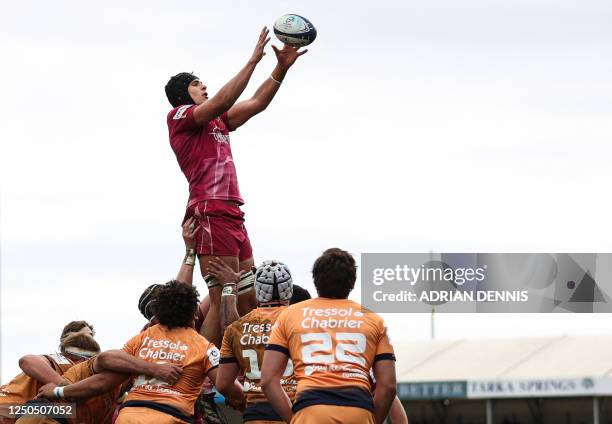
[266,297,395,411]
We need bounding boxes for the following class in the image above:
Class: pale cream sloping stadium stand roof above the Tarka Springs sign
[394,336,612,383]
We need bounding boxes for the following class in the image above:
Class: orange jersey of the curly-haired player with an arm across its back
[123,324,219,416]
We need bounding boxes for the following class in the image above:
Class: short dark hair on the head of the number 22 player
[312,247,357,299]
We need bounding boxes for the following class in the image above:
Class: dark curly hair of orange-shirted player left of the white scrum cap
[152,280,199,329]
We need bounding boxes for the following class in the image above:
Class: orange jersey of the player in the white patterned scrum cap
[220,306,297,407]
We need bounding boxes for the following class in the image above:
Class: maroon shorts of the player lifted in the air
[183,200,253,261]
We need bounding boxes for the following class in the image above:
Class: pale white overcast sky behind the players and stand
[0,0,612,382]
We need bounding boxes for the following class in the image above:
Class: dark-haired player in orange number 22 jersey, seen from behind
[261,248,396,424]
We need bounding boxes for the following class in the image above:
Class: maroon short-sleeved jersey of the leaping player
[168,105,244,205]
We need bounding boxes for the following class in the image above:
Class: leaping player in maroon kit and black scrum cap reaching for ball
[166,27,307,346]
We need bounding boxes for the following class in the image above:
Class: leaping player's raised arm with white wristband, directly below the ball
[227,45,308,131]
